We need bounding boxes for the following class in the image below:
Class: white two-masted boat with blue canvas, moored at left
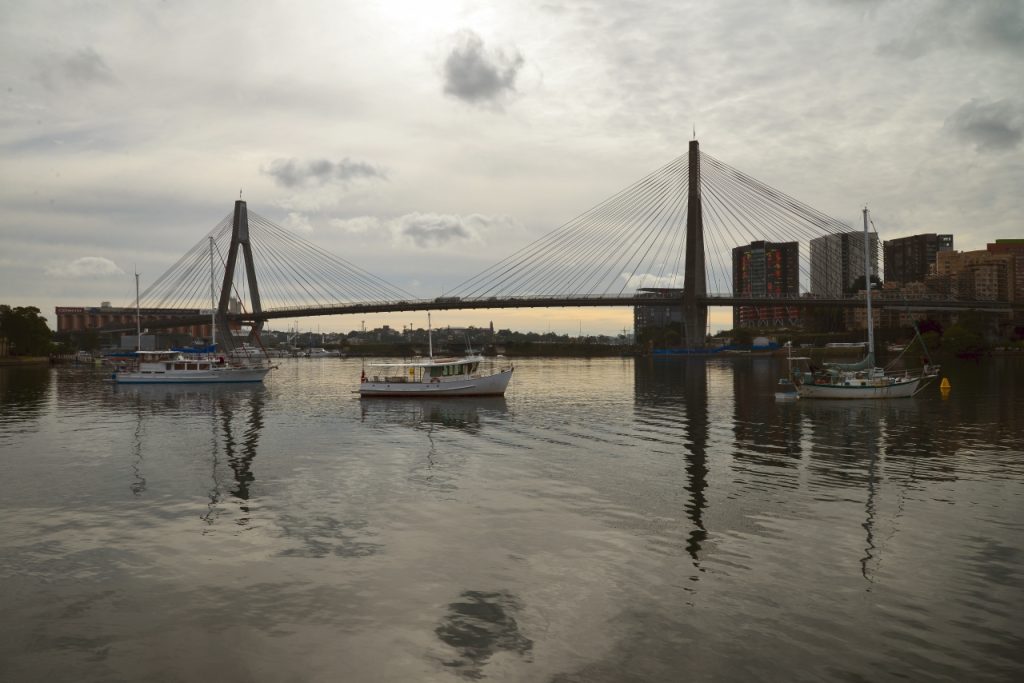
[111,238,274,384]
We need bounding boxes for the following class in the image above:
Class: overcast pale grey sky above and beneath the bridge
[0,0,1024,335]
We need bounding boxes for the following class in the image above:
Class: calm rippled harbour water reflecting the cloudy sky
[0,358,1024,683]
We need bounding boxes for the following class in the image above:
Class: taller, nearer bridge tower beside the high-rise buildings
[683,140,708,348]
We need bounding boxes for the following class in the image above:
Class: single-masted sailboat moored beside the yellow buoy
[790,207,939,399]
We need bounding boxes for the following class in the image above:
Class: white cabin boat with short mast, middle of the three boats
[359,314,515,398]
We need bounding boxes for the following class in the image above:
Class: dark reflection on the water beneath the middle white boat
[359,396,508,433]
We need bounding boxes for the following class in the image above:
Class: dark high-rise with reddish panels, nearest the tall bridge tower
[732,241,800,328]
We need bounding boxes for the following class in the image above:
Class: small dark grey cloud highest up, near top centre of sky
[444,31,523,104]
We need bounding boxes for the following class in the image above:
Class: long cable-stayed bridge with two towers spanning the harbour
[130,140,1011,348]
